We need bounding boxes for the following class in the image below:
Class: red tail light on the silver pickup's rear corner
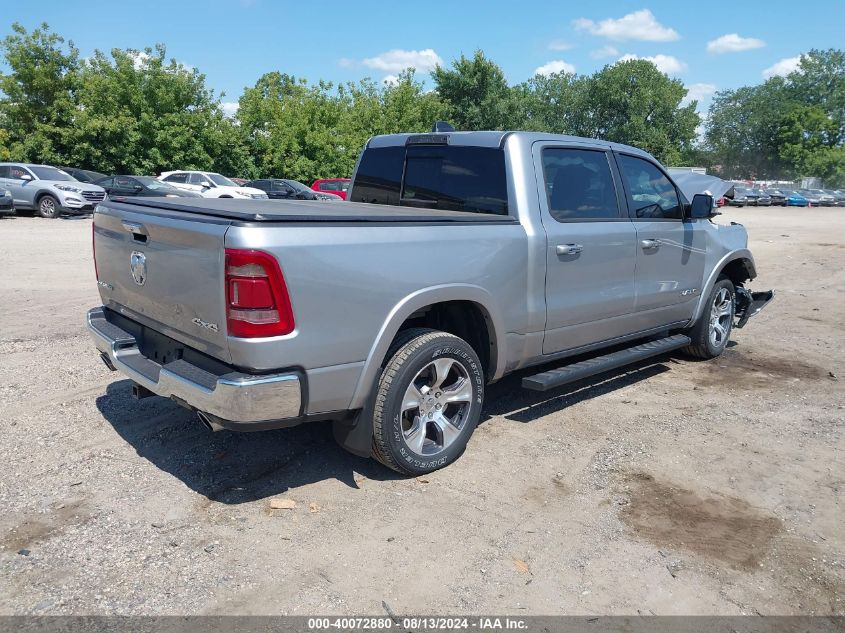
[226,248,294,338]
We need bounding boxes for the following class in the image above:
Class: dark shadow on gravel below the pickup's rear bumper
[97,380,401,504]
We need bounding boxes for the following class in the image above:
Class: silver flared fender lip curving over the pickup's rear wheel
[349,284,506,409]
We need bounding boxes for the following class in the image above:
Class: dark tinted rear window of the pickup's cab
[351,145,508,215]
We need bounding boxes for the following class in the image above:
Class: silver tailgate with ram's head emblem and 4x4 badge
[93,202,230,362]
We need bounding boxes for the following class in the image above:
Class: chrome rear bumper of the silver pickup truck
[87,308,302,430]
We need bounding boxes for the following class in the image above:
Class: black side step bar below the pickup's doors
[522,334,691,391]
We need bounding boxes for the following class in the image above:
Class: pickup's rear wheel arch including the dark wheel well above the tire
[349,284,505,410]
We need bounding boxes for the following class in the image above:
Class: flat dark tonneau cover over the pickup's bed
[102,196,517,224]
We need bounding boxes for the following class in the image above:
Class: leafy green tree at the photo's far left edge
[0,23,79,162]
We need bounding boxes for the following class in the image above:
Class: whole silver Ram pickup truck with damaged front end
[88,132,772,474]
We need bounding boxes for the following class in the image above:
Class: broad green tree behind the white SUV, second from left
[67,45,251,174]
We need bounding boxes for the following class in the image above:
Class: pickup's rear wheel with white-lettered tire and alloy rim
[372,328,484,475]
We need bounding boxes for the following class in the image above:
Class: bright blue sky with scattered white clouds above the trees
[6,0,845,119]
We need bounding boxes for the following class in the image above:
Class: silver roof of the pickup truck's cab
[367,130,651,157]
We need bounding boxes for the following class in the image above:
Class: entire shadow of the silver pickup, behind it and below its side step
[97,357,680,504]
